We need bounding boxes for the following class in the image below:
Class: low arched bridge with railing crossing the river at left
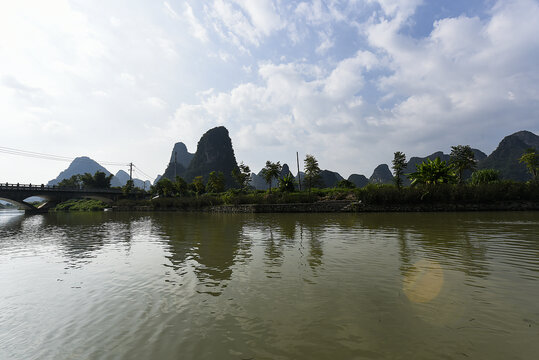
[0,183,122,212]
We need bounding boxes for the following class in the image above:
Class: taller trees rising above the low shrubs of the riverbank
[150,145,539,197]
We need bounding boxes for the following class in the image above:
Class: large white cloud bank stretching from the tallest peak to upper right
[161,1,539,176]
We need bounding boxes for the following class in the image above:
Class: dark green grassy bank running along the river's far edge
[54,181,539,211]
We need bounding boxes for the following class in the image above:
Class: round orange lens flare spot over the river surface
[402,259,444,303]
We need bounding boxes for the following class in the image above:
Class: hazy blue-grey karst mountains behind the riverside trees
[49,126,539,190]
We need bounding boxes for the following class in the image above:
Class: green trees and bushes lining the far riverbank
[51,145,539,210]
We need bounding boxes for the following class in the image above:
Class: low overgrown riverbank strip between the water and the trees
[43,182,539,213]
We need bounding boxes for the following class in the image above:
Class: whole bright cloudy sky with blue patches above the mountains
[0,0,539,184]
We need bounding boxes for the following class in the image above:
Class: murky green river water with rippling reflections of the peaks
[0,211,539,360]
